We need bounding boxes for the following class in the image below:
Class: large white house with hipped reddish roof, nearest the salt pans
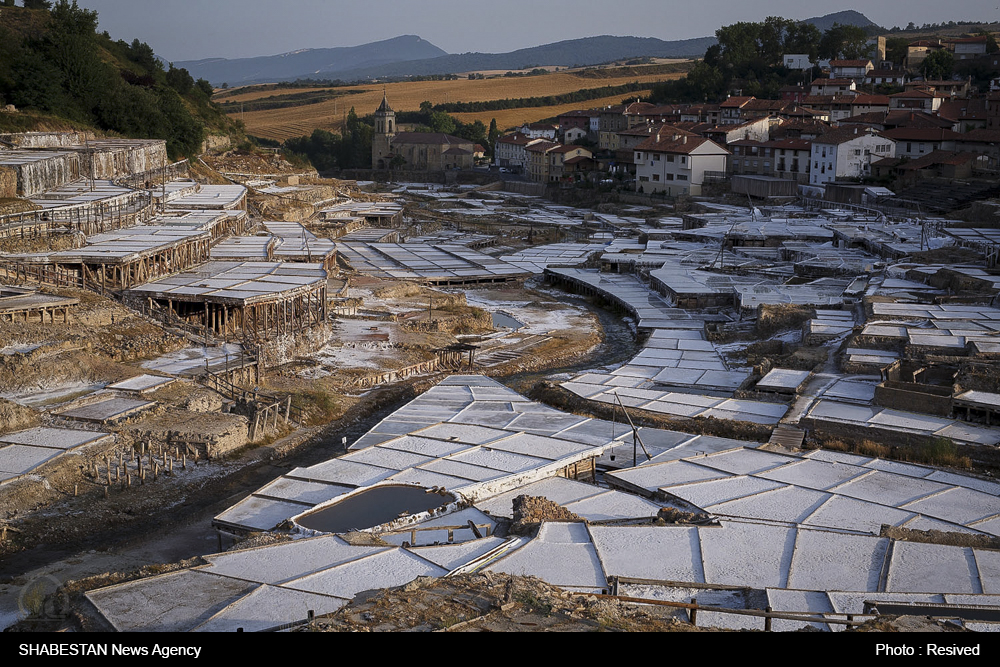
[635,134,730,196]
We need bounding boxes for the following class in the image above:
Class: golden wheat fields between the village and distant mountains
[230,67,682,141]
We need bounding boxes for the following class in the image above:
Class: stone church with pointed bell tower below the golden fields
[372,94,475,171]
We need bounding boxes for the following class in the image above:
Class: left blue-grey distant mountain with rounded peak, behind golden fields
[174,35,447,86]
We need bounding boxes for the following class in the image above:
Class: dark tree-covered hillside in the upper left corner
[0,0,242,158]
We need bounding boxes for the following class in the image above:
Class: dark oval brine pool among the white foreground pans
[296,485,455,533]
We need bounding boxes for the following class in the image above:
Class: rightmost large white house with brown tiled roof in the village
[809,126,896,186]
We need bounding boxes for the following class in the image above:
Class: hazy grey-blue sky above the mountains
[72,0,1000,61]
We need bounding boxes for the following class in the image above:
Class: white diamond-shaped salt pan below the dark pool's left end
[276,549,448,598]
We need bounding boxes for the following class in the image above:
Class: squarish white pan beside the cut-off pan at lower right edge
[888,542,983,593]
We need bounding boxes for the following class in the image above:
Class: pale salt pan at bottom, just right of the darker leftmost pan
[193,585,348,632]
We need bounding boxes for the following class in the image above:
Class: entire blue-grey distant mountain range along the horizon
[174,10,875,86]
